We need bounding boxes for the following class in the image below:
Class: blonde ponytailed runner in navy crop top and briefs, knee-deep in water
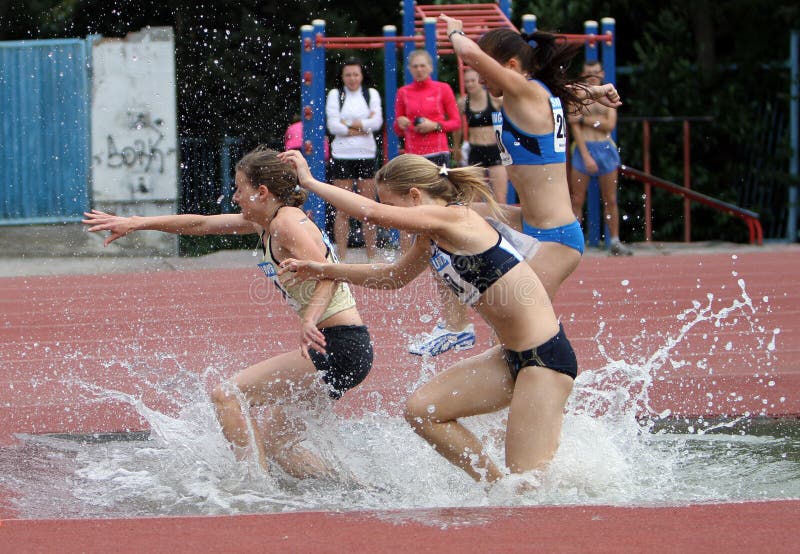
[280,151,578,482]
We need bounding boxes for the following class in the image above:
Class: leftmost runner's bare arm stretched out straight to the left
[81,210,261,246]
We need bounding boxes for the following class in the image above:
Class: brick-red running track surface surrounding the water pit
[0,247,800,552]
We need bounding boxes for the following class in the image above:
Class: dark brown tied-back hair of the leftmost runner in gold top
[236,145,308,207]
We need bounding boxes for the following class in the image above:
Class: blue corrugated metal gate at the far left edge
[0,39,91,225]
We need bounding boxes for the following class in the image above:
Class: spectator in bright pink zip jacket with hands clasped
[394,50,461,166]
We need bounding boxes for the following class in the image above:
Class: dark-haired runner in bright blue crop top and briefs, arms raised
[440,15,621,299]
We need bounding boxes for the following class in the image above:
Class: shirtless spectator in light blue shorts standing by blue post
[569,61,633,256]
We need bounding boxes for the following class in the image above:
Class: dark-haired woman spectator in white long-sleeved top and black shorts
[325,58,383,260]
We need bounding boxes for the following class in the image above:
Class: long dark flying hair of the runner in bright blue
[478,28,585,107]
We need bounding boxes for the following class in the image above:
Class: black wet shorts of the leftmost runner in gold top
[308,325,373,398]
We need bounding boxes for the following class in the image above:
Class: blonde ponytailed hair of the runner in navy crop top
[375,154,502,218]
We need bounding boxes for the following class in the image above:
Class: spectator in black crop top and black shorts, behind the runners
[453,69,508,204]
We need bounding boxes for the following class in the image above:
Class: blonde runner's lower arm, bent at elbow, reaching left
[278,238,429,290]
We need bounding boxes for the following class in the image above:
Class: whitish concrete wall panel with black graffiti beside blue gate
[91,27,179,255]
